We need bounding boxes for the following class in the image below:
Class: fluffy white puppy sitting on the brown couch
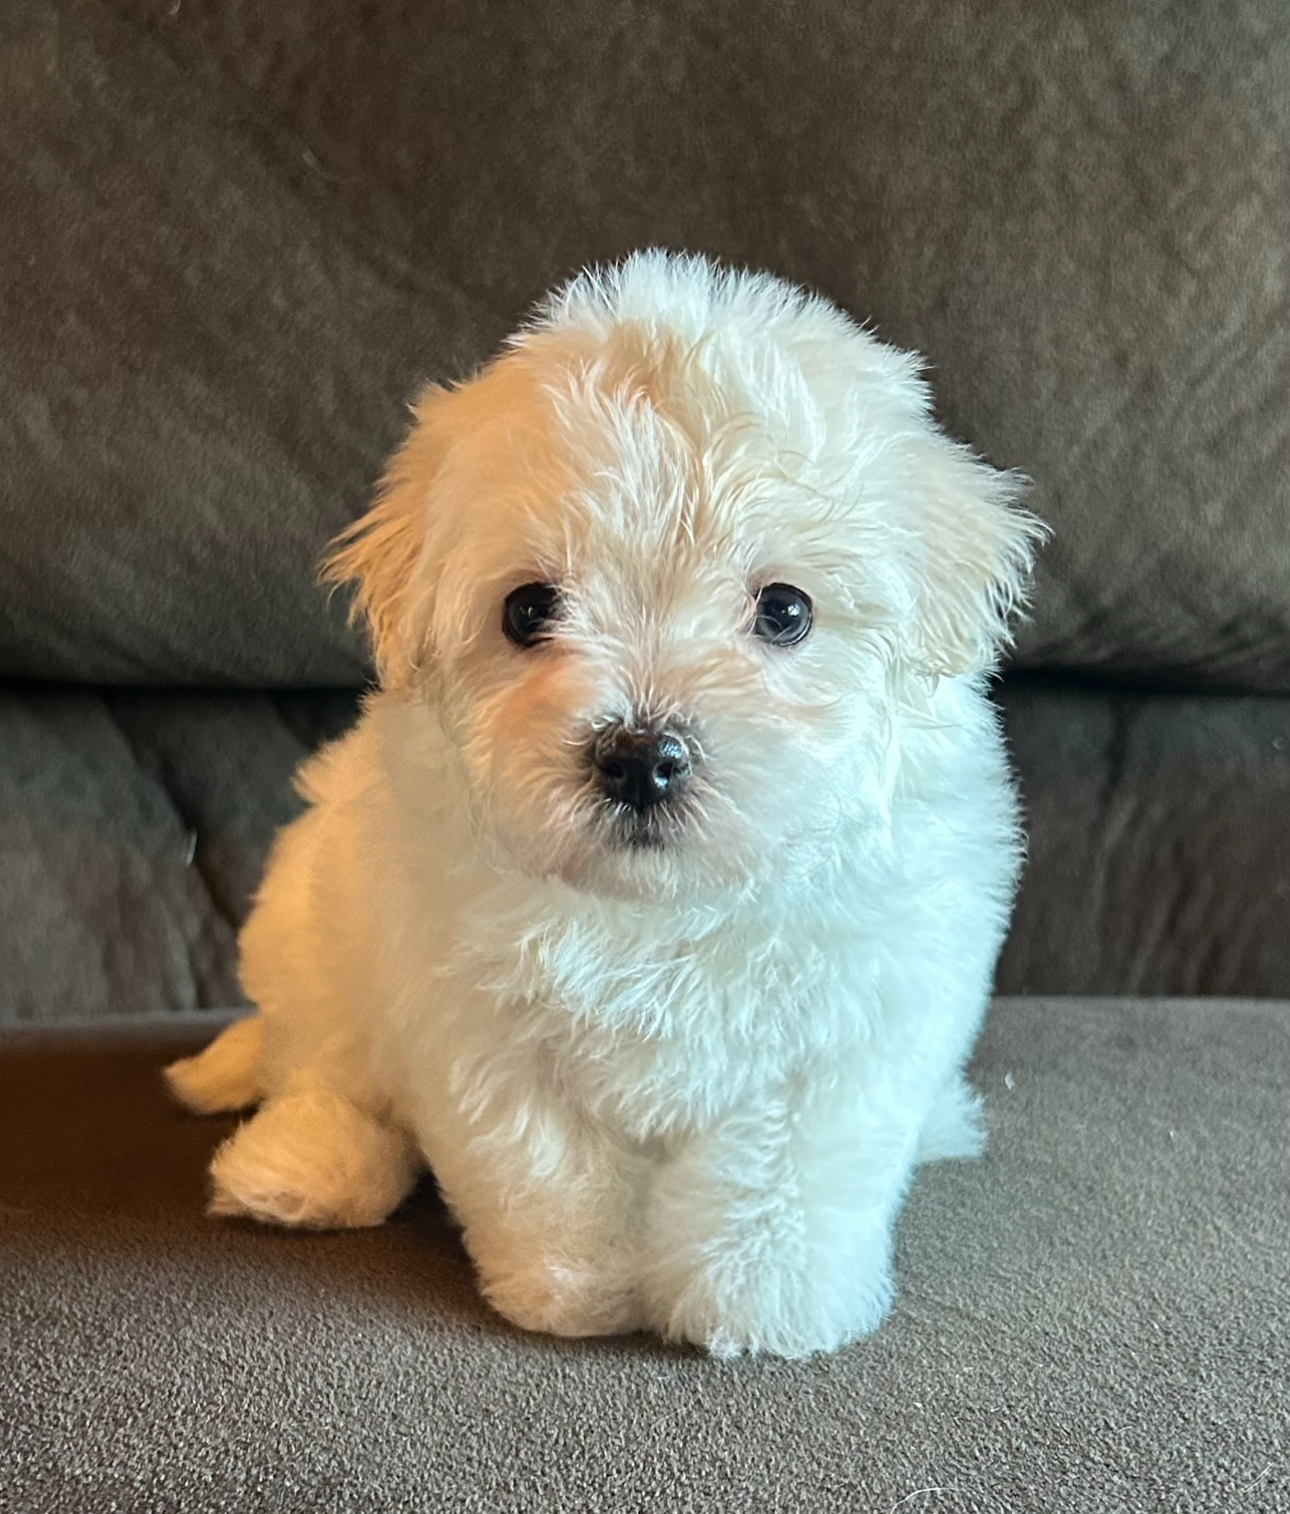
[170,253,1040,1355]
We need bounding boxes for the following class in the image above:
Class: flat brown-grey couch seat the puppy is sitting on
[0,999,1290,1514]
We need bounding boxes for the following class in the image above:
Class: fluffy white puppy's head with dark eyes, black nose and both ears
[327,254,1037,898]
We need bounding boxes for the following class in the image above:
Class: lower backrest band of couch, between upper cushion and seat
[0,680,1290,1023]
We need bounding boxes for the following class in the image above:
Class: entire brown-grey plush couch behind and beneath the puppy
[0,0,1290,1511]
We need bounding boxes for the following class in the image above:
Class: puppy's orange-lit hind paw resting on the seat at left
[210,1089,421,1229]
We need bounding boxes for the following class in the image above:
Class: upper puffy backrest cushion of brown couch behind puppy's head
[0,0,1290,690]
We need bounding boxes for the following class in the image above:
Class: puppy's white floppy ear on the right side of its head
[911,436,1048,675]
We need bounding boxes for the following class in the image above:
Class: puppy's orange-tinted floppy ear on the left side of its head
[321,386,450,689]
